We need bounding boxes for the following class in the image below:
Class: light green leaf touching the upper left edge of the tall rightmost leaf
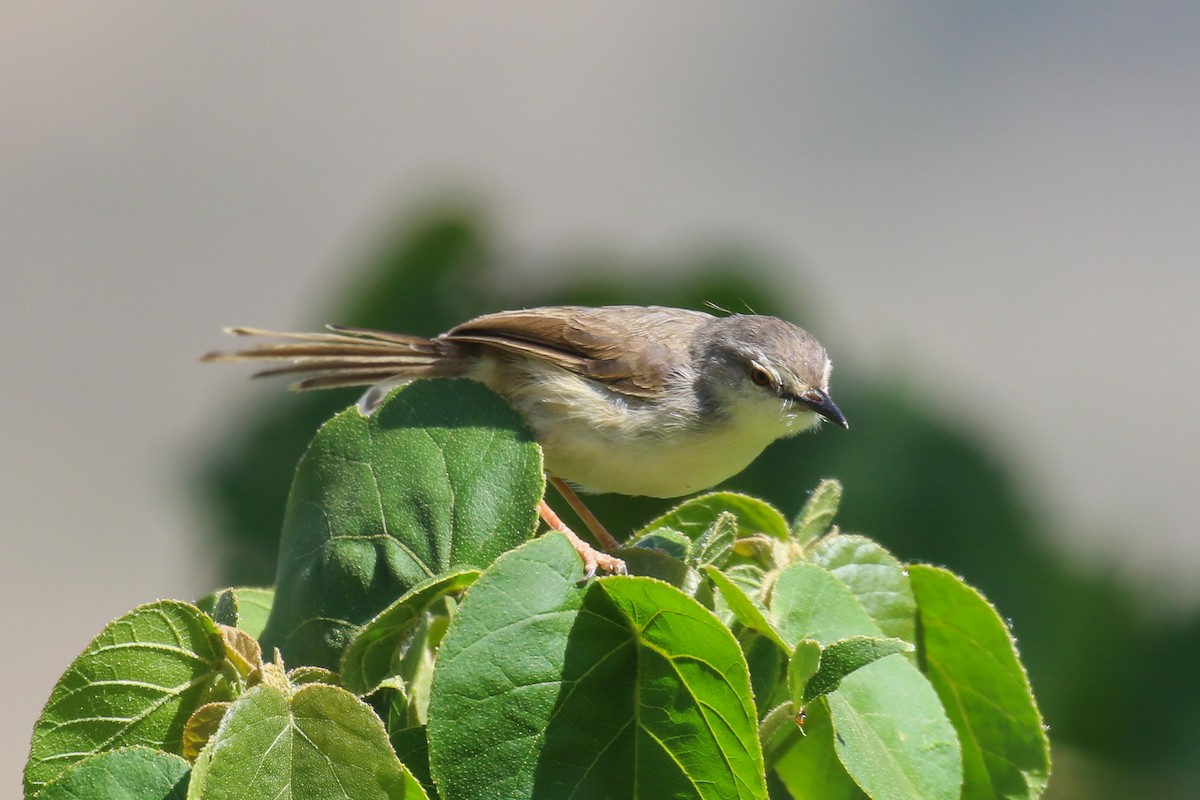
[808,534,917,643]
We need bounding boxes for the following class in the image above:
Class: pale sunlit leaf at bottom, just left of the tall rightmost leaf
[826,658,962,800]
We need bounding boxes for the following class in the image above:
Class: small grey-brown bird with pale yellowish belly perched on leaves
[200,306,850,577]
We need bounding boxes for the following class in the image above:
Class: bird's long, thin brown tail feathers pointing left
[200,325,464,399]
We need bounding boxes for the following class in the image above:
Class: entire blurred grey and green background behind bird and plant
[0,0,1200,800]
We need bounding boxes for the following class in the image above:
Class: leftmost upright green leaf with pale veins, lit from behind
[25,600,228,793]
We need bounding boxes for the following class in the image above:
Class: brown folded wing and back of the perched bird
[442,306,712,397]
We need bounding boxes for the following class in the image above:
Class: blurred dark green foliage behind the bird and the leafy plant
[198,196,1200,798]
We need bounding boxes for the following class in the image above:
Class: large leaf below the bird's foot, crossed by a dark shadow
[428,534,766,799]
